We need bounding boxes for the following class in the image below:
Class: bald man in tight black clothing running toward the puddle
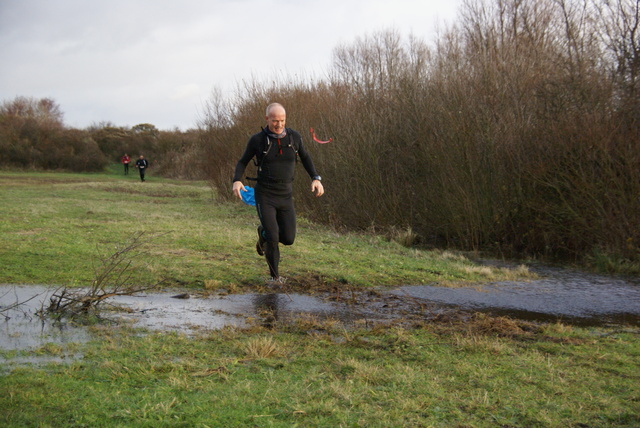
[233,103,324,283]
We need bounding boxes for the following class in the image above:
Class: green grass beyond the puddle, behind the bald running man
[0,170,524,288]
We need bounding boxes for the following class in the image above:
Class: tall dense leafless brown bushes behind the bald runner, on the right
[203,0,640,266]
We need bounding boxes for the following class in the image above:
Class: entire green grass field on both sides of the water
[0,171,640,427]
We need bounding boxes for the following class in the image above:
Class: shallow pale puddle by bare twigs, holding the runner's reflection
[0,285,392,350]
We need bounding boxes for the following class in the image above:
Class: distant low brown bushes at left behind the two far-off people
[0,97,204,179]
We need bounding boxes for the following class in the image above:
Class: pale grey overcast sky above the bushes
[0,0,462,130]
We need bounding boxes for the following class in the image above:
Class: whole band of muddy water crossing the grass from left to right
[0,266,640,350]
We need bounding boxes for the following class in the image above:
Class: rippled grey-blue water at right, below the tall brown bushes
[391,266,640,326]
